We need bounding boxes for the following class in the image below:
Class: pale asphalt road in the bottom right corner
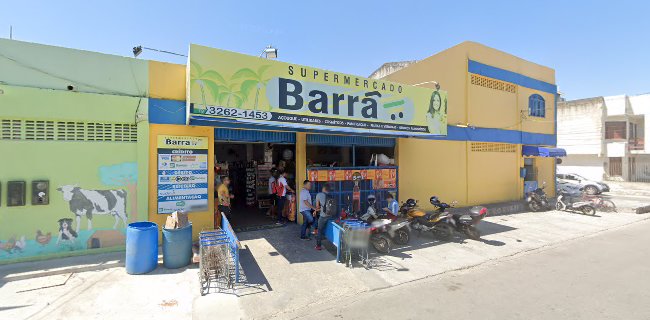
[298,216,650,320]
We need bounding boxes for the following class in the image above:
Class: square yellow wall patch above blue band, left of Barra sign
[149,61,186,100]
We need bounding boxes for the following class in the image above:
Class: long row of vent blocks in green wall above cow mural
[0,119,138,142]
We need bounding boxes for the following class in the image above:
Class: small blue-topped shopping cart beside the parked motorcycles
[341,219,370,269]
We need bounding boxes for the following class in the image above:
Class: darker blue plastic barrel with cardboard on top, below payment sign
[163,224,192,269]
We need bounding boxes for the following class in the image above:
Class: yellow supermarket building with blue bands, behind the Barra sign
[149,42,557,228]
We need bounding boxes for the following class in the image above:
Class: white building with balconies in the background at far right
[557,94,650,182]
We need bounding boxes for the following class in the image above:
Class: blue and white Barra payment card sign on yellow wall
[157,135,209,213]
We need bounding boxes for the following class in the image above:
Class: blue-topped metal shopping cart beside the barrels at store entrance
[199,229,235,295]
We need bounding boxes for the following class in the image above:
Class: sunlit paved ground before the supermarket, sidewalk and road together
[0,201,650,320]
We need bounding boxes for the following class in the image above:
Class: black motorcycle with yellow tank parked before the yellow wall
[400,196,455,241]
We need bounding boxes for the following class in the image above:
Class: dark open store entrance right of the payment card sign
[214,141,296,231]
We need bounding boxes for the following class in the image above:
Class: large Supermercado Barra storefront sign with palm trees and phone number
[187,45,447,136]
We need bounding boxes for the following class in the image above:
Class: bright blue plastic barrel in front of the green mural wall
[125,221,158,274]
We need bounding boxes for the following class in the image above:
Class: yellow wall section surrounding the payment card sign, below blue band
[149,124,214,240]
